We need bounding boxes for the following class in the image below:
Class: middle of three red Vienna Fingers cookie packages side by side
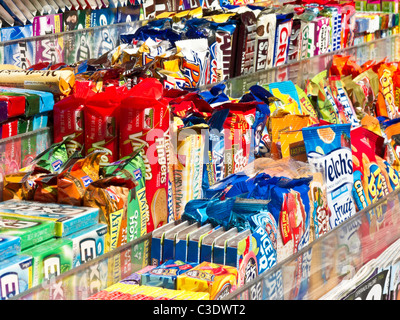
[84,86,128,166]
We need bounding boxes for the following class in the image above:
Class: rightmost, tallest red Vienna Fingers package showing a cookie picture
[119,78,173,232]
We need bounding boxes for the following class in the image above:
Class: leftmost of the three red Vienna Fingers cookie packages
[53,81,95,156]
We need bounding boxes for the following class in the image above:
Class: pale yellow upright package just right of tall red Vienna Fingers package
[173,124,208,220]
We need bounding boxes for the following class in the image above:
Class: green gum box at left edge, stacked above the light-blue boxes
[0,214,56,250]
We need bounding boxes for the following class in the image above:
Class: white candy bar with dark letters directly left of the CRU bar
[254,13,276,72]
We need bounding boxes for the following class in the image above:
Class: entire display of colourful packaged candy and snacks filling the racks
[0,1,400,300]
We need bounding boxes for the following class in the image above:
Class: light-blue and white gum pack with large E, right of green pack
[67,223,107,268]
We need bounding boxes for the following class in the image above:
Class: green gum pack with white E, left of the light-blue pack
[22,238,73,286]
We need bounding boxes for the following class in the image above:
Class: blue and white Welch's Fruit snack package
[303,124,355,228]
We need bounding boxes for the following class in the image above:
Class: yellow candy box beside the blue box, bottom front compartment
[176,262,238,300]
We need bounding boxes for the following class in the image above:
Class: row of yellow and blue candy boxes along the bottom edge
[88,260,238,300]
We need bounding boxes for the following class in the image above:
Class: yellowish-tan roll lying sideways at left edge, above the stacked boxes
[0,70,75,95]
